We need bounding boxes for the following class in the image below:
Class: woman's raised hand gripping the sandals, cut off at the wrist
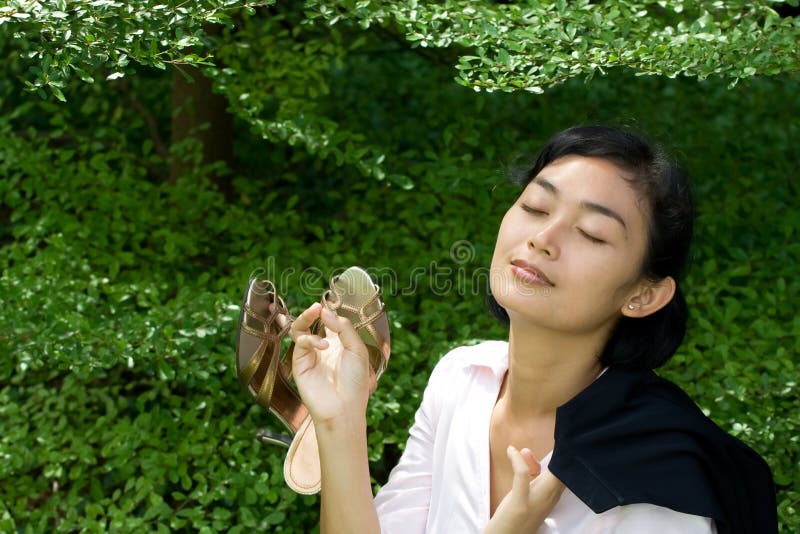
[289,302,375,426]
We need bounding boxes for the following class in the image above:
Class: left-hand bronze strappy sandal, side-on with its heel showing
[236,279,308,446]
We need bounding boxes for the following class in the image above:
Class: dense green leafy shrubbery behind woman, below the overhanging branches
[0,2,800,533]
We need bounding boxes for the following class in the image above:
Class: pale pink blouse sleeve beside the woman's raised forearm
[375,362,442,534]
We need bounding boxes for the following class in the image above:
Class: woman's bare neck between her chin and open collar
[501,322,608,418]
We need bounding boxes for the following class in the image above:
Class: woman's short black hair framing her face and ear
[488,126,694,369]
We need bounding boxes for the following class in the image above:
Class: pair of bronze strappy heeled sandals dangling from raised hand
[236,267,391,495]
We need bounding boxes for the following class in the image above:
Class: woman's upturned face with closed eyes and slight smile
[490,156,647,334]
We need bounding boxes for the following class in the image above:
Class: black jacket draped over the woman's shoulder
[549,369,778,534]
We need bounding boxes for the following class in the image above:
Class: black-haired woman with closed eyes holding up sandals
[290,126,777,534]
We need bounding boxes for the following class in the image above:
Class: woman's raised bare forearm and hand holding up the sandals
[284,303,381,534]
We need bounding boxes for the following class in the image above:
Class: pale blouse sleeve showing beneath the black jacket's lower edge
[614,504,717,534]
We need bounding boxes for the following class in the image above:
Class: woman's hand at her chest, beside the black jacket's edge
[483,446,564,534]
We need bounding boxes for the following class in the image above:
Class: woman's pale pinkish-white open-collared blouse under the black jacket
[375,341,716,534]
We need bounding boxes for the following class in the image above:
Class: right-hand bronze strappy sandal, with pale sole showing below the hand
[283,267,391,495]
